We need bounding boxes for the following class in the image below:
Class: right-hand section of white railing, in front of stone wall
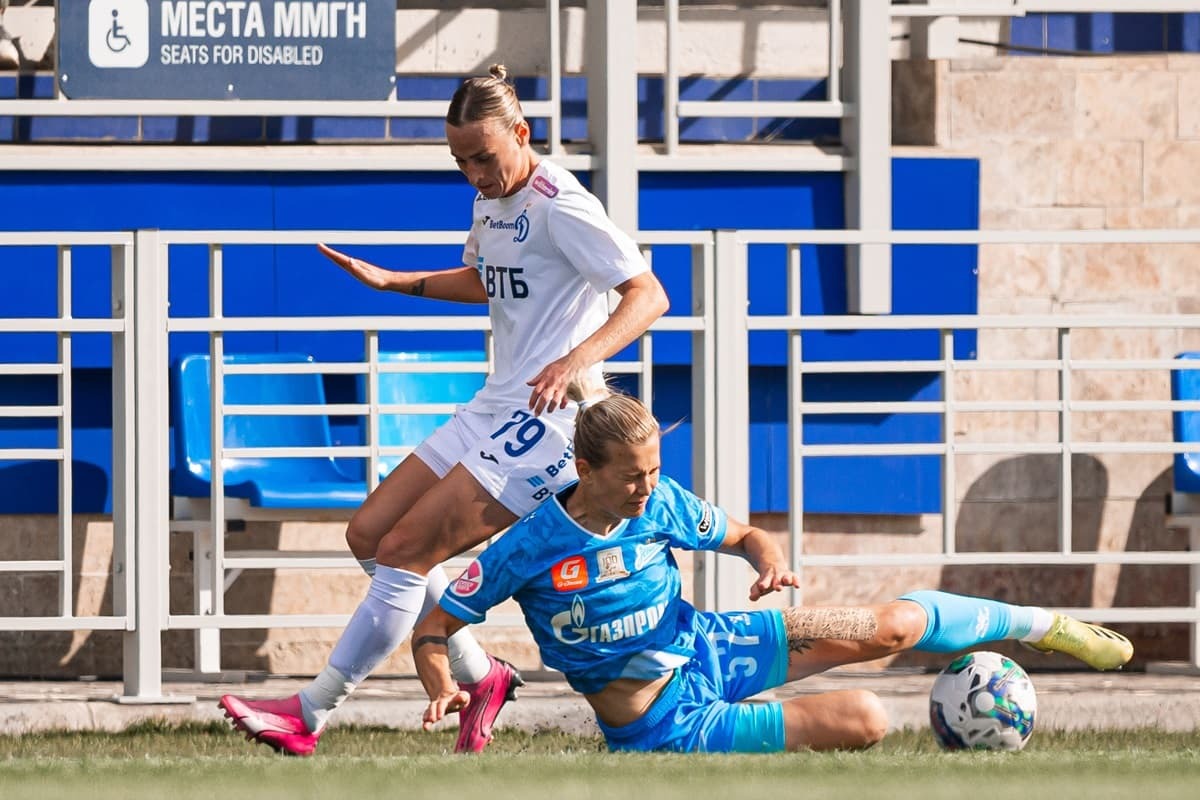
[713,230,1200,664]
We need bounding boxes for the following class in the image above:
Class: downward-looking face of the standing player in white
[446,120,533,200]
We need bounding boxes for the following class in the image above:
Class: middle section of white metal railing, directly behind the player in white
[150,230,714,686]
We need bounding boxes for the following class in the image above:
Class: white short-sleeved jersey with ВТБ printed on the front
[463,161,650,410]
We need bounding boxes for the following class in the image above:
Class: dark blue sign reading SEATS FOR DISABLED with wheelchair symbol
[58,0,396,100]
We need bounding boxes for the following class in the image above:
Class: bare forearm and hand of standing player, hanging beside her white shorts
[528,272,671,414]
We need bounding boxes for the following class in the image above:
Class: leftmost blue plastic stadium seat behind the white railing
[170,353,366,509]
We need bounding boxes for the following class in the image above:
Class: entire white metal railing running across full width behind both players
[7,224,1200,699]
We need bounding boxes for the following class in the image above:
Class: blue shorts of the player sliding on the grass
[599,609,787,753]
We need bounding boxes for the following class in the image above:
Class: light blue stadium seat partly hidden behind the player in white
[379,350,487,480]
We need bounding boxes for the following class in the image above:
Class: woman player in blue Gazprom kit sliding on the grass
[413,395,1133,752]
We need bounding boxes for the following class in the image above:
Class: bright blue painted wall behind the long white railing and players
[0,160,978,513]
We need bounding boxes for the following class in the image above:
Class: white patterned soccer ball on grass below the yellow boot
[929,650,1038,751]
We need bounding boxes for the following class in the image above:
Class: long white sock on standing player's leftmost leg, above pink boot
[300,565,425,732]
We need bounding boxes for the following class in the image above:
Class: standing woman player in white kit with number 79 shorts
[220,66,667,756]
